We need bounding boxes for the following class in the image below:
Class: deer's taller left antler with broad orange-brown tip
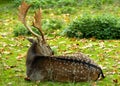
[18,1,39,37]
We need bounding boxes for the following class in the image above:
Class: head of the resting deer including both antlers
[19,2,53,56]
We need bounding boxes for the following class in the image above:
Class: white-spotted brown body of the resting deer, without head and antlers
[26,44,104,82]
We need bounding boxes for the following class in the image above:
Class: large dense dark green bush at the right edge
[64,14,120,39]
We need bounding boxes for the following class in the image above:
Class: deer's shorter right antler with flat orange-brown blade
[33,8,46,42]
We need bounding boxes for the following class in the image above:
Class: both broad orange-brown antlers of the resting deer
[19,2,45,41]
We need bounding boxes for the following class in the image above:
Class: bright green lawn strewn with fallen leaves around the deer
[0,1,120,86]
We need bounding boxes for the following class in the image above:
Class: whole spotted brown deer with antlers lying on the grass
[19,2,105,82]
